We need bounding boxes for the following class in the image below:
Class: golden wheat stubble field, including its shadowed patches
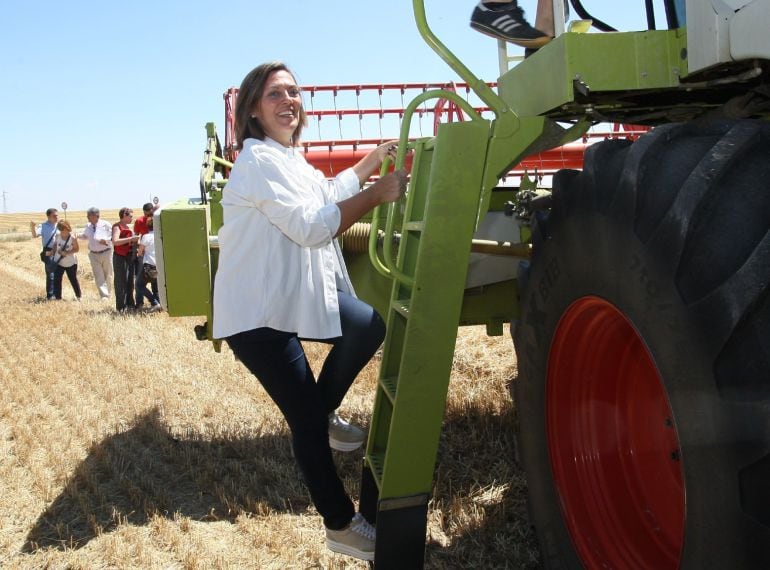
[0,232,539,569]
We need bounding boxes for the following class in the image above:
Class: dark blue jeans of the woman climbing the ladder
[227,291,385,529]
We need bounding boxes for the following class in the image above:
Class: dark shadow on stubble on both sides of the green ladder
[22,398,540,570]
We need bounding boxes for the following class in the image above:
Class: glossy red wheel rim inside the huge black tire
[546,297,685,570]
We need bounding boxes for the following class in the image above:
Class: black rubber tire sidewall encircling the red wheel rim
[513,118,770,569]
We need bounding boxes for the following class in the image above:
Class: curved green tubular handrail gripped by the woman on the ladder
[369,89,483,287]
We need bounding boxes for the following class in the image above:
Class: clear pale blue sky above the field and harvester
[0,0,664,212]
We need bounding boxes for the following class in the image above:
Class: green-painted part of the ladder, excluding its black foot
[366,120,490,500]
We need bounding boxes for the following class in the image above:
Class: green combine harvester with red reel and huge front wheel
[159,0,770,570]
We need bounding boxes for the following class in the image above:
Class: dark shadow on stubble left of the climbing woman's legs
[22,409,309,553]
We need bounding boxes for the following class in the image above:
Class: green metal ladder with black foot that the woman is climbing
[361,103,490,568]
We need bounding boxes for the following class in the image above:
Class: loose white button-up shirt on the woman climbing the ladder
[214,138,360,339]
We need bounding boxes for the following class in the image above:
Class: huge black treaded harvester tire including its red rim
[513,120,770,570]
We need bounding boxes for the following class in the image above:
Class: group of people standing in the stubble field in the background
[30,203,161,312]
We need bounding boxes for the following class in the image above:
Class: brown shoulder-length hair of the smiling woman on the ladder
[235,61,307,150]
